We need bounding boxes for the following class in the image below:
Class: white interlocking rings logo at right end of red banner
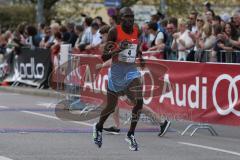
[212,74,240,116]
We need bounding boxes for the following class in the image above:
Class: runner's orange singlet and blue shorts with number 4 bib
[108,25,141,92]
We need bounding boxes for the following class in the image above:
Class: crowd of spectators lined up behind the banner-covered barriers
[0,3,240,63]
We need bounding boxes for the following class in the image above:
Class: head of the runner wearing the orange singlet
[120,7,134,30]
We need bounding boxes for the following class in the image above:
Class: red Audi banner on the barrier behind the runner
[75,56,240,126]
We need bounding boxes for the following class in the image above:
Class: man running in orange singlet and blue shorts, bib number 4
[93,7,143,151]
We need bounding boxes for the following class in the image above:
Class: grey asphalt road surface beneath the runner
[0,91,240,160]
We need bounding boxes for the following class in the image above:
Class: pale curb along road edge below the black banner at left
[0,86,64,98]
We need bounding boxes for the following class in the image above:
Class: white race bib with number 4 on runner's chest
[118,44,137,63]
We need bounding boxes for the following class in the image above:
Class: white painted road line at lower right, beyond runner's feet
[178,142,240,156]
